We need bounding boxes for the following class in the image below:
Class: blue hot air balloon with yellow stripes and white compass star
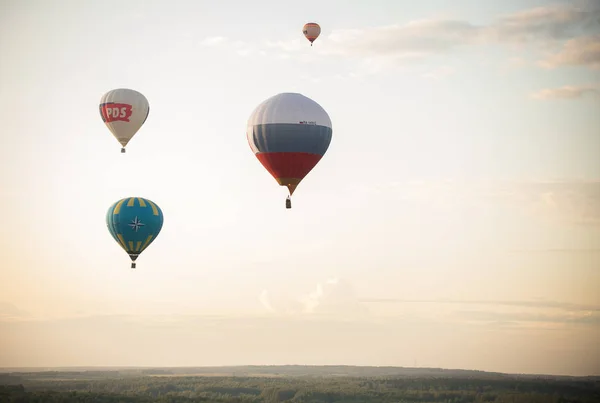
[106,197,163,269]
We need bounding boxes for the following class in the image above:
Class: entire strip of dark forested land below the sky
[0,366,600,403]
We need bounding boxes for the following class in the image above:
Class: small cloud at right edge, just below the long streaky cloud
[540,35,600,69]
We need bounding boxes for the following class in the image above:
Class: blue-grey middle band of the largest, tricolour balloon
[250,123,332,156]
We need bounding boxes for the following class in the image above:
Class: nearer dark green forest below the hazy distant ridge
[0,376,600,403]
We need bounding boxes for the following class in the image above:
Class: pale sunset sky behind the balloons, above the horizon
[0,0,600,375]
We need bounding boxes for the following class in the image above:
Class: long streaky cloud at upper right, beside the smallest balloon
[323,5,600,60]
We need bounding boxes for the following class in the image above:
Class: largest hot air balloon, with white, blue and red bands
[246,93,332,208]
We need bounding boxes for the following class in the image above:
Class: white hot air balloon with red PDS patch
[99,88,150,153]
